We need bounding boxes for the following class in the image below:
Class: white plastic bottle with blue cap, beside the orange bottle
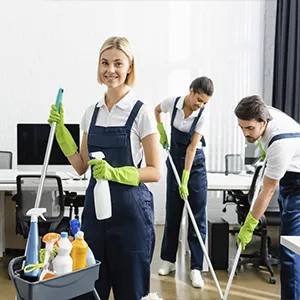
[53,232,73,276]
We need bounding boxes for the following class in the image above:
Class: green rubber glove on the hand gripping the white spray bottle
[88,159,140,186]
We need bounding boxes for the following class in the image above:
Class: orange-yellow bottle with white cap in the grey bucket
[71,231,88,271]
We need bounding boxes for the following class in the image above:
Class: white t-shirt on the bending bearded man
[261,106,300,180]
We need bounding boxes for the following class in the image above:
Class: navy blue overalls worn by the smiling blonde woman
[77,101,155,300]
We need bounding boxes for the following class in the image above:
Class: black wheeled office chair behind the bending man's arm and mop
[226,165,281,284]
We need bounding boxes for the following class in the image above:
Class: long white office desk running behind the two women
[0,170,252,258]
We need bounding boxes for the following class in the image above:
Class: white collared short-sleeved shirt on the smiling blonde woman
[81,91,156,166]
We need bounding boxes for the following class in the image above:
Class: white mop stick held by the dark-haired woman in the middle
[166,149,223,299]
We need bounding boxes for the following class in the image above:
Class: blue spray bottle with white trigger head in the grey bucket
[24,208,46,281]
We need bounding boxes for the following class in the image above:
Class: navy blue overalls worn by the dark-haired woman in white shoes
[161,97,207,271]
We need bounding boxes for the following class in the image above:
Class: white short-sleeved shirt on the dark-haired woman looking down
[161,97,207,149]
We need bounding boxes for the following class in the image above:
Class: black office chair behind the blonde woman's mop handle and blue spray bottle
[14,175,69,239]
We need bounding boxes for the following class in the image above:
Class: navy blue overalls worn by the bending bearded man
[268,133,300,300]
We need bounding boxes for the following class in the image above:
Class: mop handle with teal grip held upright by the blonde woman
[34,88,64,208]
